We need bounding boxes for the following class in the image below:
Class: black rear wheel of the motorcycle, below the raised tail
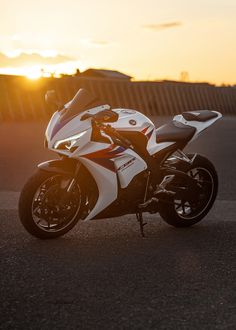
[159,155,218,227]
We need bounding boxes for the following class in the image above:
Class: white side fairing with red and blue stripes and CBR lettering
[77,142,147,220]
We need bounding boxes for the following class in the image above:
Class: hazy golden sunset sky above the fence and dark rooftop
[0,0,236,85]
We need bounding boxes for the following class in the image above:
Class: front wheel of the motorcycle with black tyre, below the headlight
[19,170,84,239]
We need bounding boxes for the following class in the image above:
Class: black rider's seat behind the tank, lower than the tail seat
[156,121,196,143]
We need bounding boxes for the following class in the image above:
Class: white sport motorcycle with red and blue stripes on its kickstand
[19,89,222,239]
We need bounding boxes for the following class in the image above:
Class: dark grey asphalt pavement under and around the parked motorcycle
[0,118,236,329]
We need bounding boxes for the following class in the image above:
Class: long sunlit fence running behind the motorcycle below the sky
[0,76,236,121]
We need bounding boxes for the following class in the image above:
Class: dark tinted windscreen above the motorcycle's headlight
[61,88,102,121]
